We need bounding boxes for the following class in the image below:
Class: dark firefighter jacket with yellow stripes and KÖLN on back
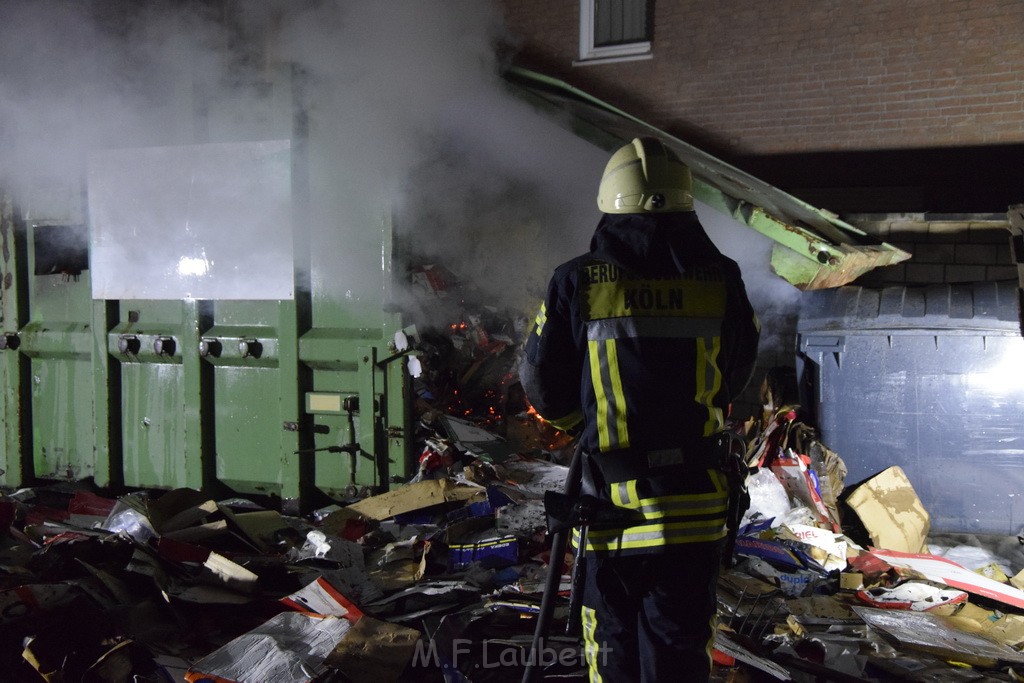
[520,212,760,550]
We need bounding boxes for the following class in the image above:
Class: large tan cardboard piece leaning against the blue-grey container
[846,466,931,553]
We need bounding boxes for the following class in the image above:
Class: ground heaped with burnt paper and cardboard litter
[0,274,1024,683]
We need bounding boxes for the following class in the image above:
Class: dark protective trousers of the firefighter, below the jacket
[582,542,721,683]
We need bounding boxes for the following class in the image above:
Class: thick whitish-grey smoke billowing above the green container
[0,0,796,362]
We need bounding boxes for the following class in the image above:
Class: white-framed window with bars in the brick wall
[580,0,651,61]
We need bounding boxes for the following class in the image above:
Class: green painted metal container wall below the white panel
[0,194,412,508]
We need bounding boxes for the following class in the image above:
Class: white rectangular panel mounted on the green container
[88,140,295,299]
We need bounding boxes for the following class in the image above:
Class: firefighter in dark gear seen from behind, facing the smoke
[520,138,760,681]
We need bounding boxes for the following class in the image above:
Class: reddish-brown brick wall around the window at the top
[501,0,1024,155]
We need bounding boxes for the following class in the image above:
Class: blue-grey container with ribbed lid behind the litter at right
[797,283,1024,533]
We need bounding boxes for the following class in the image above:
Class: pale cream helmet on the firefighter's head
[597,137,693,213]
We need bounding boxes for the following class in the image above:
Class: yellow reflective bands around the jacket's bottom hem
[587,470,729,554]
